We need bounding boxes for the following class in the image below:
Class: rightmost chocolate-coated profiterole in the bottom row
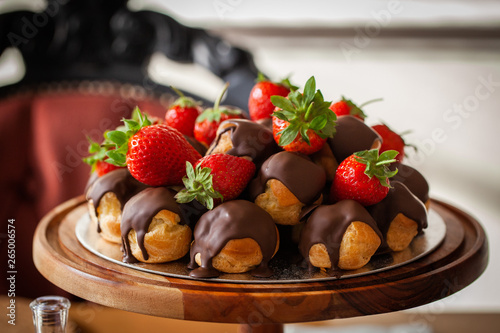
[367,181,427,252]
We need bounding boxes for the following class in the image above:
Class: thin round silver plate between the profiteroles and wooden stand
[75,209,446,283]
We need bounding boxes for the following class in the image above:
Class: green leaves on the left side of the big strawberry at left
[103,107,151,167]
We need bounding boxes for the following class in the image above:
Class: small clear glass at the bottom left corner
[30,296,71,333]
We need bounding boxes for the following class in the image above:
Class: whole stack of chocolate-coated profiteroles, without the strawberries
[86,76,429,278]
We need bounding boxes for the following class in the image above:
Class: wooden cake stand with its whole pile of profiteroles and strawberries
[33,77,488,332]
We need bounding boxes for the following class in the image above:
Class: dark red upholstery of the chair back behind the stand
[0,91,165,297]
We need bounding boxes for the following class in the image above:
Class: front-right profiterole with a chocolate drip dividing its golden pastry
[299,200,382,270]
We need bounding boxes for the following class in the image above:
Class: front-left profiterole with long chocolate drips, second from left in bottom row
[121,187,196,263]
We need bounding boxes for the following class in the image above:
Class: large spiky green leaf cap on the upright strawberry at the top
[271,76,337,146]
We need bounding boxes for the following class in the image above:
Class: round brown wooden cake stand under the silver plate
[33,197,488,332]
